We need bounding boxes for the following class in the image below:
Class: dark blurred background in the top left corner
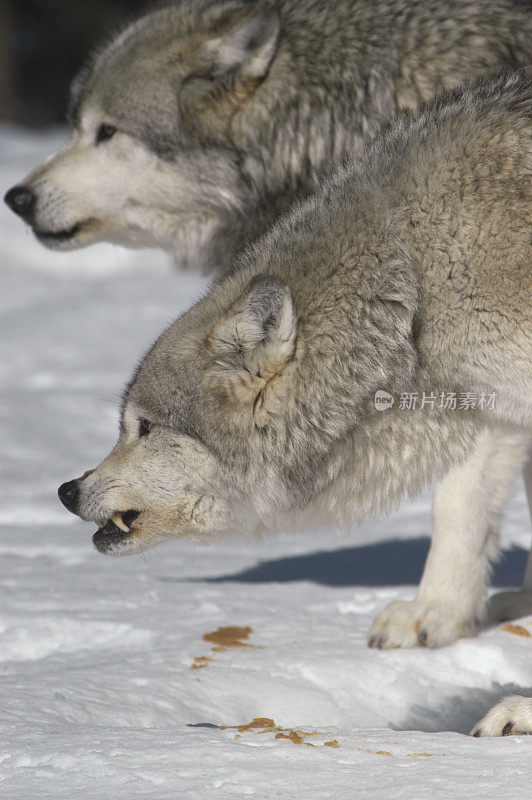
[0,0,153,128]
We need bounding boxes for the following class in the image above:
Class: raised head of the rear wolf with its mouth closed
[5,0,279,267]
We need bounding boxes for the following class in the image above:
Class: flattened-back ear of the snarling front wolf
[211,275,297,388]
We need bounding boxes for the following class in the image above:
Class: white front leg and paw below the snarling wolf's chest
[369,431,527,648]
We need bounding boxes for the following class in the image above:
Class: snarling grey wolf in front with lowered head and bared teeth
[59,71,532,730]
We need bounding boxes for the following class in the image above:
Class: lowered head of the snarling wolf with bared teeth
[59,276,306,555]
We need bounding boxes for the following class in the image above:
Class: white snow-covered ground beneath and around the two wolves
[0,129,532,800]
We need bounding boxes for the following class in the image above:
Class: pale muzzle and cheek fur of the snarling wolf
[73,406,256,555]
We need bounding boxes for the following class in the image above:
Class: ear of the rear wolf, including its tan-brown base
[180,0,280,131]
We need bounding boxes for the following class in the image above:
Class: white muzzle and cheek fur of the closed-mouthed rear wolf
[17,106,244,263]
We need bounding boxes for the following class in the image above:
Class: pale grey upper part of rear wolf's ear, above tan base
[202,2,280,80]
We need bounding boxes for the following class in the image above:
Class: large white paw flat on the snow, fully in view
[368,600,475,650]
